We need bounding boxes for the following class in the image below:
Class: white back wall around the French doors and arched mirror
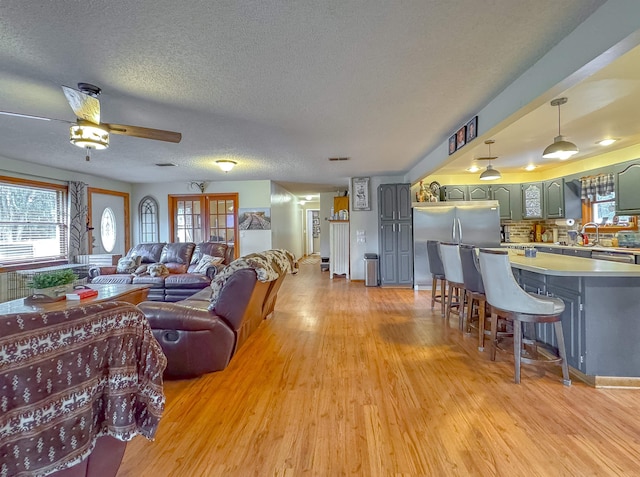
[131,180,271,255]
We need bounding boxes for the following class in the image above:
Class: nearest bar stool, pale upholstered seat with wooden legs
[480,249,571,386]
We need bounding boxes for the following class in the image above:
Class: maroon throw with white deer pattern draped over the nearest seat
[0,302,166,477]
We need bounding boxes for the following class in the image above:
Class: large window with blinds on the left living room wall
[0,177,67,265]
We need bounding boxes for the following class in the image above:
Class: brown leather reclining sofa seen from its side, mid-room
[138,250,297,378]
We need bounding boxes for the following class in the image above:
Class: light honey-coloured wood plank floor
[118,263,640,477]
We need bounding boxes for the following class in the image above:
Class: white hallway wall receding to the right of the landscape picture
[271,183,304,258]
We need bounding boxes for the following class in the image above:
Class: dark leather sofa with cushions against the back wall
[89,242,234,302]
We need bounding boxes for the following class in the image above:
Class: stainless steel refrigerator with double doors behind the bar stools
[413,200,500,290]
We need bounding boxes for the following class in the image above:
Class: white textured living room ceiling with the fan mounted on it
[0,0,604,193]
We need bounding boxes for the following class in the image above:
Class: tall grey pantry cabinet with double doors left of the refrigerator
[378,184,413,287]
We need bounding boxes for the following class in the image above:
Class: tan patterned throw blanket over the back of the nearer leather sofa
[209,249,298,311]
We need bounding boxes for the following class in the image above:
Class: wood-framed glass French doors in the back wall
[169,194,239,257]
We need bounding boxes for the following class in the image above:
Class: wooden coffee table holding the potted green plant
[0,283,150,315]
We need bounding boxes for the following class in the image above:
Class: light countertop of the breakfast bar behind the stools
[509,250,640,278]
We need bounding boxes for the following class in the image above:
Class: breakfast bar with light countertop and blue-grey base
[509,250,640,387]
